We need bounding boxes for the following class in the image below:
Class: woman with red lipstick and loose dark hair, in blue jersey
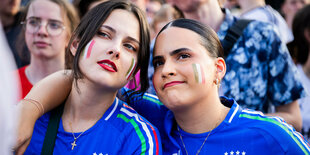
[17,0,161,155]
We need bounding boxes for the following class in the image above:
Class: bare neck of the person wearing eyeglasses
[25,57,65,85]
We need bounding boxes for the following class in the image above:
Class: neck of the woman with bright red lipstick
[62,79,117,132]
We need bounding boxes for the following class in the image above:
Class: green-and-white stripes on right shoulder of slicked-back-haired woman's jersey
[239,114,310,154]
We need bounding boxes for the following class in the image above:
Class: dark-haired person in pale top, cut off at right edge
[288,4,310,142]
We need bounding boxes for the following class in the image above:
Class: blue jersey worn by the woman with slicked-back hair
[122,89,310,155]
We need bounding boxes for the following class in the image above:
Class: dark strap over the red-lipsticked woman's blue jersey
[41,103,65,155]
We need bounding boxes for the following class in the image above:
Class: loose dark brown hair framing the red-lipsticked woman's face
[66,0,150,92]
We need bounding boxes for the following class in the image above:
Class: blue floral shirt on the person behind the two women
[217,10,305,112]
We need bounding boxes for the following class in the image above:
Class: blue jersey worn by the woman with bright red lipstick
[25,98,162,155]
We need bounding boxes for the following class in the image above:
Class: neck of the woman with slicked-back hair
[174,92,229,134]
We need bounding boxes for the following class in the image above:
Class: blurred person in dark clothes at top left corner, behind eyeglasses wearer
[0,0,30,68]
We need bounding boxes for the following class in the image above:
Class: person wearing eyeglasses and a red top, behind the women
[18,0,79,98]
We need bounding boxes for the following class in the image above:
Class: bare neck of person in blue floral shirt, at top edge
[184,1,225,31]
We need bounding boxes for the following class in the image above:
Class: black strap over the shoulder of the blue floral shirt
[222,19,253,58]
